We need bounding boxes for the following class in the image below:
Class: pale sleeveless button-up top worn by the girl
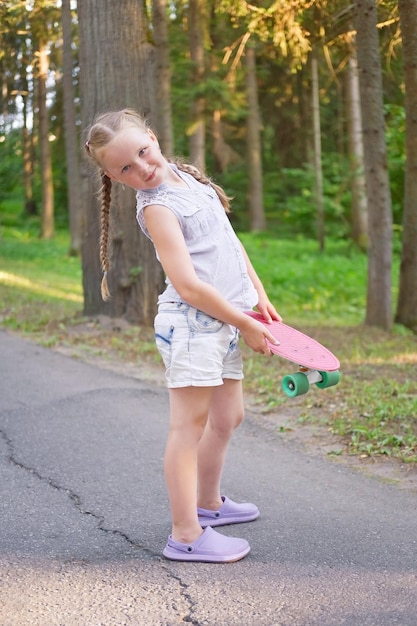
[136,163,258,311]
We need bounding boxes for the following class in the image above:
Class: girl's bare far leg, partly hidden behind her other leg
[197,379,244,510]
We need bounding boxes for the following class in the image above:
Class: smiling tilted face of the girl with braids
[98,126,175,189]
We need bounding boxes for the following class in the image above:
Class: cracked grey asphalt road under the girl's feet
[0,330,417,626]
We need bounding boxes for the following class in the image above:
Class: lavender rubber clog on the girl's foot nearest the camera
[162,526,250,563]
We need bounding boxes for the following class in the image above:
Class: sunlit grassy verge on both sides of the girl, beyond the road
[0,202,417,464]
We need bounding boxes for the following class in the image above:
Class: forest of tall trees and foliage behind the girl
[0,0,417,459]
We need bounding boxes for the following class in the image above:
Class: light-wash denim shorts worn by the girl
[154,302,243,388]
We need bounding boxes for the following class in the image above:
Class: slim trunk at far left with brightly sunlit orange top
[38,41,55,239]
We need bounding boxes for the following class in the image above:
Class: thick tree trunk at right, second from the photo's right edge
[355,0,392,329]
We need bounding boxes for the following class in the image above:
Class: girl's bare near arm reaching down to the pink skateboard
[144,205,278,355]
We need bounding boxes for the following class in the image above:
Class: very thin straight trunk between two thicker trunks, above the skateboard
[311,46,325,252]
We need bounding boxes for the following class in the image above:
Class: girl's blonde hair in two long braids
[85,109,231,300]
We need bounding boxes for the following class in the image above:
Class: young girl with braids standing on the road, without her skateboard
[85,109,281,562]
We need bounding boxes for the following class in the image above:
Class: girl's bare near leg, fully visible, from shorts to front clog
[165,380,213,543]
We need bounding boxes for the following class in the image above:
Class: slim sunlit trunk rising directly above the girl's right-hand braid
[188,0,206,172]
